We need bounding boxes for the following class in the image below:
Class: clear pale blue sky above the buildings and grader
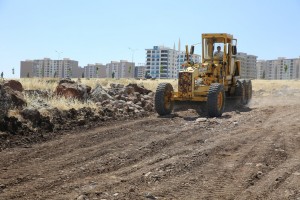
[0,0,300,78]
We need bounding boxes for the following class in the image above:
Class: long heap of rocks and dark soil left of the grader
[0,79,154,149]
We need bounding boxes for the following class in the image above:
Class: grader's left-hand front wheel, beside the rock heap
[154,83,174,116]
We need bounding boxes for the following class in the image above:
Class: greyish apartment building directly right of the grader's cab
[236,52,257,79]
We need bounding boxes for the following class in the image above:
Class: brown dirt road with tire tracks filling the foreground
[0,93,300,199]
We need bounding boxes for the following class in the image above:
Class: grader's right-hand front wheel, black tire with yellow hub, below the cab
[207,83,225,117]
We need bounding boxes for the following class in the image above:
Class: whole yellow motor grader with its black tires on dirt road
[155,33,252,117]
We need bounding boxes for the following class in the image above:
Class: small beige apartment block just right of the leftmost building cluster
[84,63,108,78]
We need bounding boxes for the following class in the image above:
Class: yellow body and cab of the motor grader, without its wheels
[172,33,240,101]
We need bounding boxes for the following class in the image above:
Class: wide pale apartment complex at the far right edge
[256,57,300,80]
